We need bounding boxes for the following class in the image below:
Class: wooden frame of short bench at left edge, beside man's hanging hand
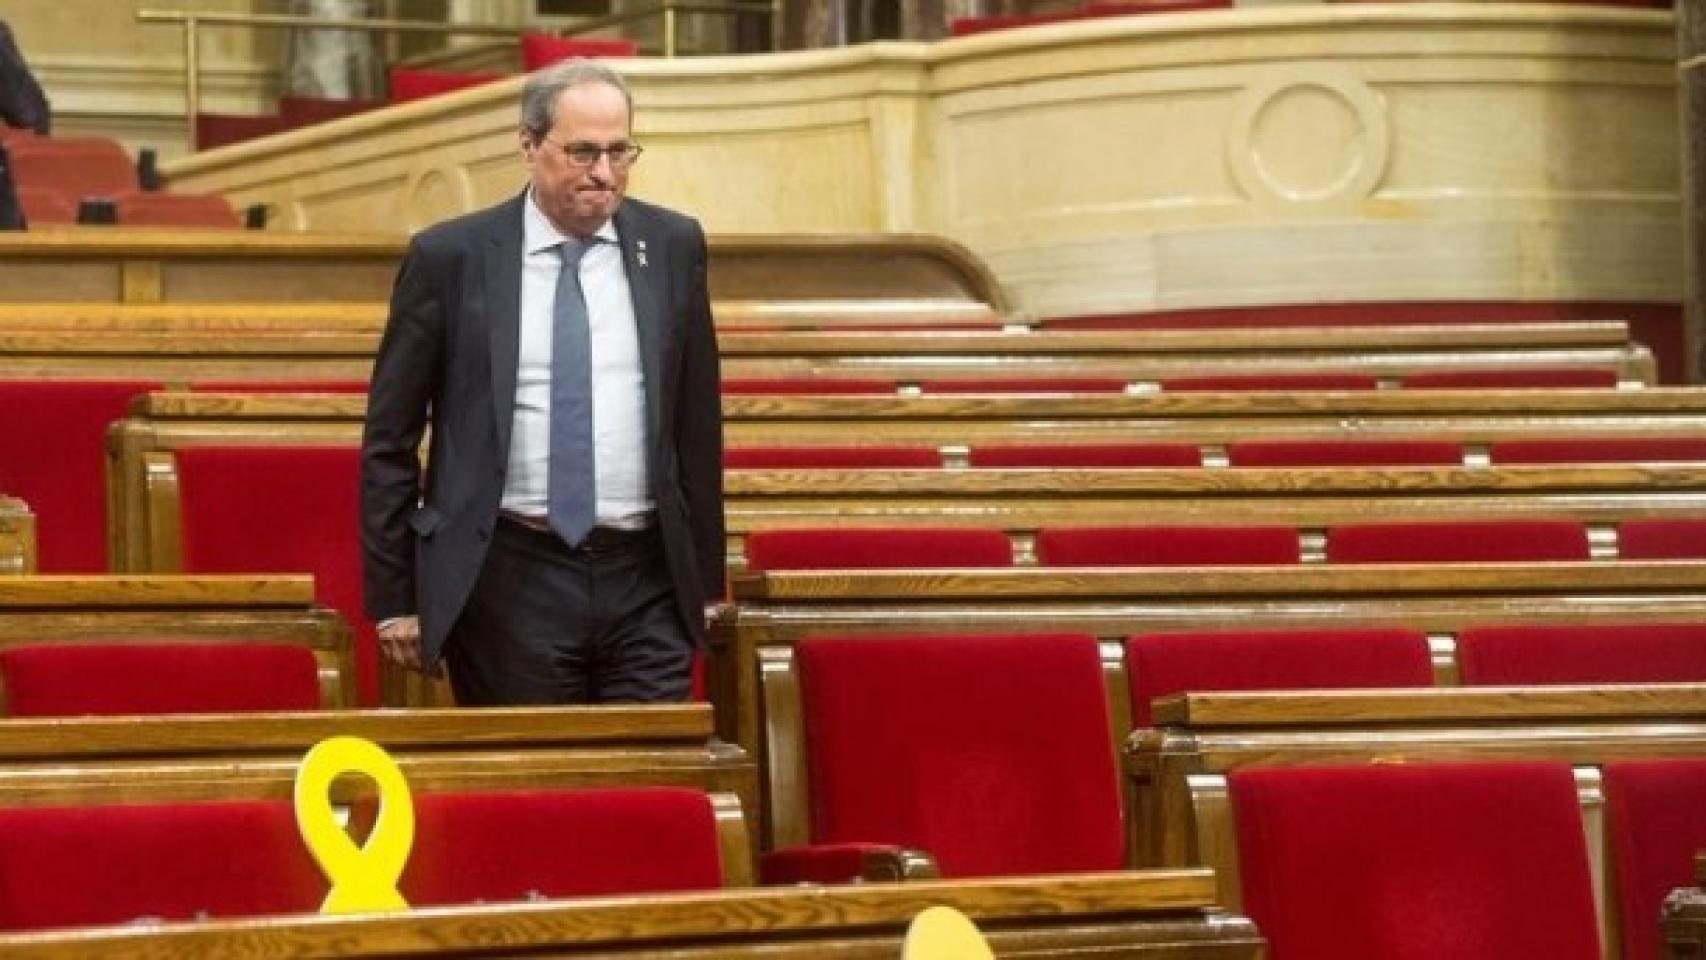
[0,576,355,705]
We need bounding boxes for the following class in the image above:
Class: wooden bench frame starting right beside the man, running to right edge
[736,561,1706,846]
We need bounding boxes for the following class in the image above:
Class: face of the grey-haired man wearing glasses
[520,84,631,237]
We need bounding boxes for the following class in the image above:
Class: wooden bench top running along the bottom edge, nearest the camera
[0,870,1262,960]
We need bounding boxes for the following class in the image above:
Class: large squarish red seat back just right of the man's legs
[795,634,1124,876]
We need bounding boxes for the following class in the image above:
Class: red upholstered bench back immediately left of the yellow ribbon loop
[0,801,326,931]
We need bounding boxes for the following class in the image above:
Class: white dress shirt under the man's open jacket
[502,189,653,527]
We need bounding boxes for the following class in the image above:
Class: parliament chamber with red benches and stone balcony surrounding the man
[0,0,1706,960]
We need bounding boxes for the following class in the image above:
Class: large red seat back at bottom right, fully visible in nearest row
[1227,764,1600,960]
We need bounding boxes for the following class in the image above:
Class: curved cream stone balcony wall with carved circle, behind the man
[169,3,1682,314]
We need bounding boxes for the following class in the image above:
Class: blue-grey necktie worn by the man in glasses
[546,239,599,546]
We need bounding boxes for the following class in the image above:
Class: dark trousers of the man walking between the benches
[445,518,693,706]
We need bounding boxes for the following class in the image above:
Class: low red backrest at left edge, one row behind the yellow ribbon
[0,641,321,716]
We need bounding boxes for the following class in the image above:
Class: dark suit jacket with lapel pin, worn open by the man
[362,196,723,663]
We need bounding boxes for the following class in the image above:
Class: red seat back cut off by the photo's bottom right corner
[1602,759,1706,960]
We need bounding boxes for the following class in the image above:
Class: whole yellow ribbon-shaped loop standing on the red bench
[295,737,415,914]
